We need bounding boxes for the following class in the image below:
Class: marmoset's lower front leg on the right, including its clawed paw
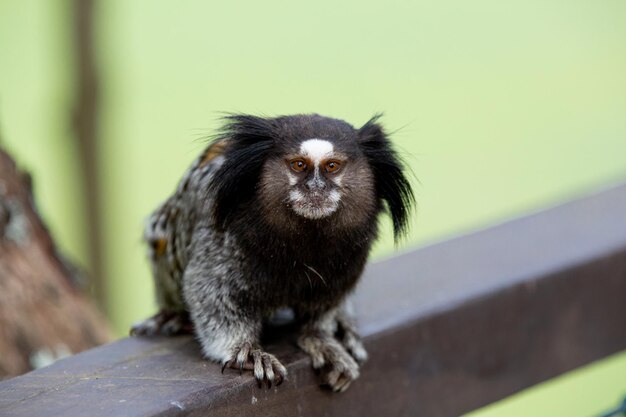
[298,307,367,392]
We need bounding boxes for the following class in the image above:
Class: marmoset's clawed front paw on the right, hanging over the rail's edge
[298,334,358,392]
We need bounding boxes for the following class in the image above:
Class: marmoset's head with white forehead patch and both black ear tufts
[211,114,413,237]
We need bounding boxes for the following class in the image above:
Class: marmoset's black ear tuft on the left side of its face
[209,114,274,230]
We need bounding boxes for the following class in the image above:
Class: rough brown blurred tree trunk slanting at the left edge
[0,150,111,378]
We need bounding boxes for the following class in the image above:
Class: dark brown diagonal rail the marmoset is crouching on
[0,184,626,417]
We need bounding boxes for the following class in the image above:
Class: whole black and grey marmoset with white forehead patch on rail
[131,114,414,391]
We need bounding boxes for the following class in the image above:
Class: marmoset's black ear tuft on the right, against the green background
[358,114,415,243]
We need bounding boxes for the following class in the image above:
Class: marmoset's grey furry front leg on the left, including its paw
[184,268,287,387]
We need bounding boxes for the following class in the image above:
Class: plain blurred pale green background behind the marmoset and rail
[0,0,626,417]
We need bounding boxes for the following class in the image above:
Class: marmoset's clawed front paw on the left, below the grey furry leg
[222,342,287,388]
